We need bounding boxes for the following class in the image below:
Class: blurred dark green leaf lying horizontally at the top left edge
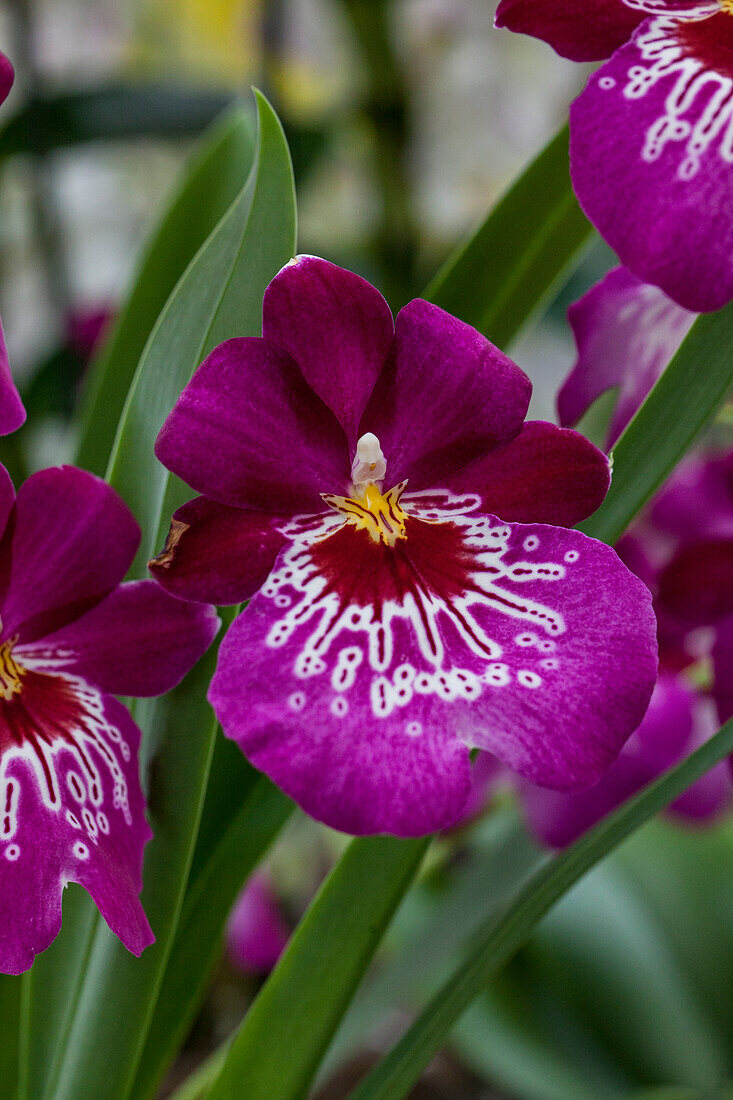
[0,84,231,158]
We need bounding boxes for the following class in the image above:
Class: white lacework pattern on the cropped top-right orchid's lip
[599,9,733,180]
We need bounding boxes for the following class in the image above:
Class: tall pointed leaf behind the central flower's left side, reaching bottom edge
[37,95,295,1100]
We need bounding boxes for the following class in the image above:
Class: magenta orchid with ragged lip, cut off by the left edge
[0,466,218,974]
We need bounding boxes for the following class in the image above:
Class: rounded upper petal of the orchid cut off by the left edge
[0,466,140,641]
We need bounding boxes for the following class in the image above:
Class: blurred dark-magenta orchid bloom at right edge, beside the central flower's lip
[512,451,733,847]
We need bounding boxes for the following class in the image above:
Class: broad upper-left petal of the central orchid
[155,338,350,513]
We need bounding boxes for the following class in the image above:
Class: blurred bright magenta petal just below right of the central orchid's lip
[521,677,696,848]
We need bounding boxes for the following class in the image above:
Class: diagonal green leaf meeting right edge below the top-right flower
[579,305,733,543]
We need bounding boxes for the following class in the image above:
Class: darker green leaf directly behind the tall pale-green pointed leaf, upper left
[77,107,254,474]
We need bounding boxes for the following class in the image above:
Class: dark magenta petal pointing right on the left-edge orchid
[21,581,219,696]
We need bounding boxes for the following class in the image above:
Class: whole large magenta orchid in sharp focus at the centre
[151,256,656,835]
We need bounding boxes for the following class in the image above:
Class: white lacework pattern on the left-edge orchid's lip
[0,668,132,861]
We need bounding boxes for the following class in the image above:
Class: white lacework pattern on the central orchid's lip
[261,490,580,737]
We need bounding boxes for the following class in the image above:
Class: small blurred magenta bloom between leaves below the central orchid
[226,871,291,974]
